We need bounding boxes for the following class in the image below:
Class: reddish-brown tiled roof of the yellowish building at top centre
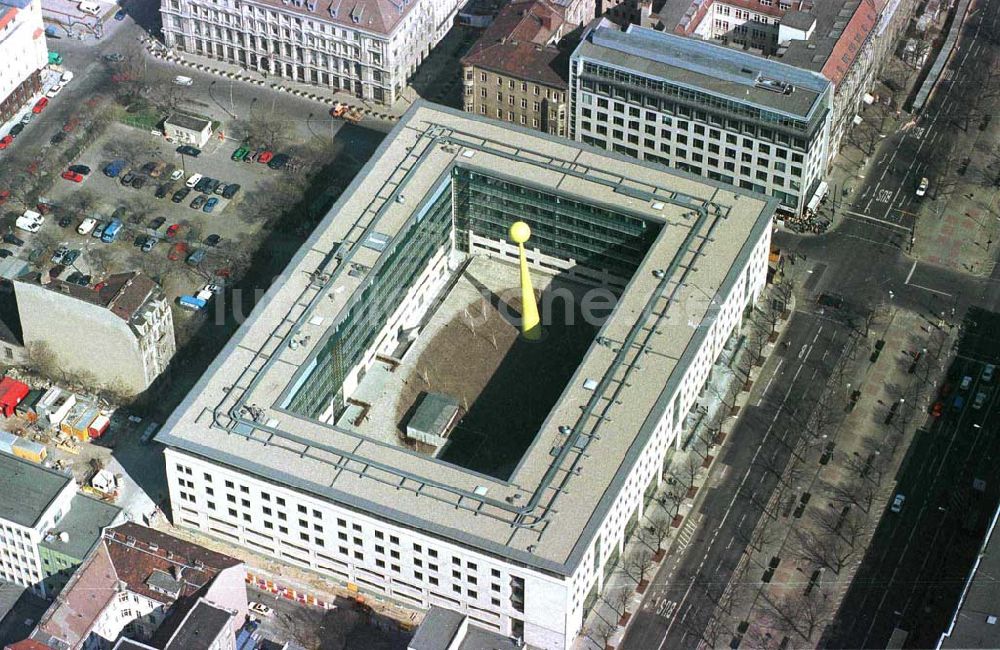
[462,0,568,87]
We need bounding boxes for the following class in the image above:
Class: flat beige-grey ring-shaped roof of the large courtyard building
[157,102,777,575]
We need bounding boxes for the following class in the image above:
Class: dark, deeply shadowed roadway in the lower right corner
[823,314,1000,648]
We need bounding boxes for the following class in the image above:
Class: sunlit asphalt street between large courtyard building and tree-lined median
[622,311,850,650]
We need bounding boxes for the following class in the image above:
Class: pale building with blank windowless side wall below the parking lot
[14,271,176,394]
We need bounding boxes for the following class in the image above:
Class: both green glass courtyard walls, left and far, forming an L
[288,167,661,418]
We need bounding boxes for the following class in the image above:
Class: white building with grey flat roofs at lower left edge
[0,452,122,598]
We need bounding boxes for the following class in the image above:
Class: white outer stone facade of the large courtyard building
[164,221,770,649]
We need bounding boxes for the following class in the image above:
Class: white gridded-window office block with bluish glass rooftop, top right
[570,24,833,214]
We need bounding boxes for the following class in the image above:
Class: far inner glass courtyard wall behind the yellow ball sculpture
[453,167,660,278]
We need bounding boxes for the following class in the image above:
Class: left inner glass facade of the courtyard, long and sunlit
[288,183,451,418]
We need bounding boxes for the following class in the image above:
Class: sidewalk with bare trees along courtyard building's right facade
[573,284,794,650]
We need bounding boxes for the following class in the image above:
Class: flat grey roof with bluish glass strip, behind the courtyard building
[573,25,830,121]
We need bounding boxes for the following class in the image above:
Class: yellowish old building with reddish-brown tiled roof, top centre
[462,0,572,136]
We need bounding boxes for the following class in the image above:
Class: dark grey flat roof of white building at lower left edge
[0,452,73,528]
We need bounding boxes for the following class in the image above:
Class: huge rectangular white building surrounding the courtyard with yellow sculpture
[157,103,775,647]
